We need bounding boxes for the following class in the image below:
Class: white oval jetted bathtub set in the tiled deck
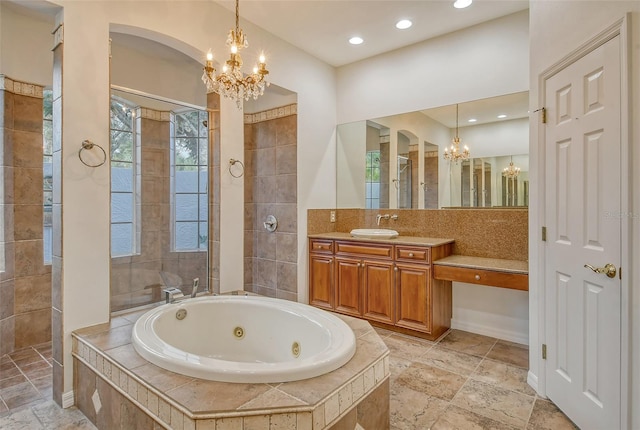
[132,296,356,383]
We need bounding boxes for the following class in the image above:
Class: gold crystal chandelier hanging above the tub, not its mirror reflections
[202,0,269,109]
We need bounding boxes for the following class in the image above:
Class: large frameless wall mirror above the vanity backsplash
[336,92,529,209]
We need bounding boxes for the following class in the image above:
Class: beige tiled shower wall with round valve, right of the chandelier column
[244,105,298,301]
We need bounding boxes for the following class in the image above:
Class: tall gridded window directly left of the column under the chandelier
[171,110,209,251]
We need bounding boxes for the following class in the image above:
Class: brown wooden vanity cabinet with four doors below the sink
[309,239,451,339]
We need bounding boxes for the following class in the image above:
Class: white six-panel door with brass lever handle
[545,36,623,429]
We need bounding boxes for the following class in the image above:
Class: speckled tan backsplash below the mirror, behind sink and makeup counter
[307,208,529,261]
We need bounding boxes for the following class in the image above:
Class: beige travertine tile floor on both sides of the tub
[0,329,576,430]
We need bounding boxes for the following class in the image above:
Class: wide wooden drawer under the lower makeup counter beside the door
[433,265,529,291]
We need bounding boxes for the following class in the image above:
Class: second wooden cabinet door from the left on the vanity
[335,257,362,317]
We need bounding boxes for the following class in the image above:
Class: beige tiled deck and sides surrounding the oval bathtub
[73,312,389,430]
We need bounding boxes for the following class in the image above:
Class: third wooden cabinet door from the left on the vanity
[362,260,395,324]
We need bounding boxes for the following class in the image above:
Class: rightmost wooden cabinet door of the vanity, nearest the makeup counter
[396,264,431,333]
